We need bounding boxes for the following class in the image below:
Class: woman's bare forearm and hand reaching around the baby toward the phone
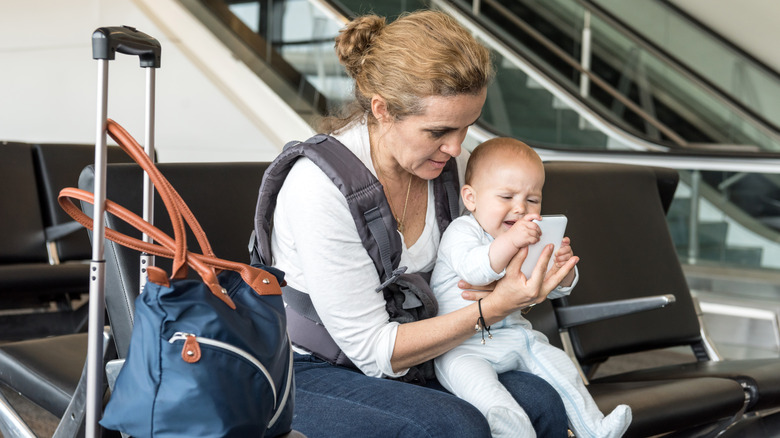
[391,245,579,370]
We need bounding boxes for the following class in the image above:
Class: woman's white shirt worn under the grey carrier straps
[271,122,468,377]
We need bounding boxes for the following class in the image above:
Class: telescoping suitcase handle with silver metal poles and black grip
[85,26,161,438]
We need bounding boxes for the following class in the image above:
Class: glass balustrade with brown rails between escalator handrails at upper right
[458,0,780,152]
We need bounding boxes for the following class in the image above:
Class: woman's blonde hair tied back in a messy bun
[321,10,493,132]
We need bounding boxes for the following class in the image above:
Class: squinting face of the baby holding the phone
[466,159,544,238]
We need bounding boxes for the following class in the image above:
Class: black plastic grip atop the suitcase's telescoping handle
[92,26,162,68]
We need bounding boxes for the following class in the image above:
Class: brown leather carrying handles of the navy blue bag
[58,119,281,308]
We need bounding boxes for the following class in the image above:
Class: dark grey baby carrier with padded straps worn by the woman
[252,134,459,383]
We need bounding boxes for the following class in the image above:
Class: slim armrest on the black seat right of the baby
[555,294,676,329]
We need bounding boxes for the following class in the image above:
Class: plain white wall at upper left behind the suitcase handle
[0,0,311,161]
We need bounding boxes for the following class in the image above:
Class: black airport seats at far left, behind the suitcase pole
[0,142,128,341]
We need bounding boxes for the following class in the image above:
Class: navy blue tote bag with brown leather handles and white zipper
[60,121,295,437]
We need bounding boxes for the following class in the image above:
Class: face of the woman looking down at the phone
[379,89,487,180]
